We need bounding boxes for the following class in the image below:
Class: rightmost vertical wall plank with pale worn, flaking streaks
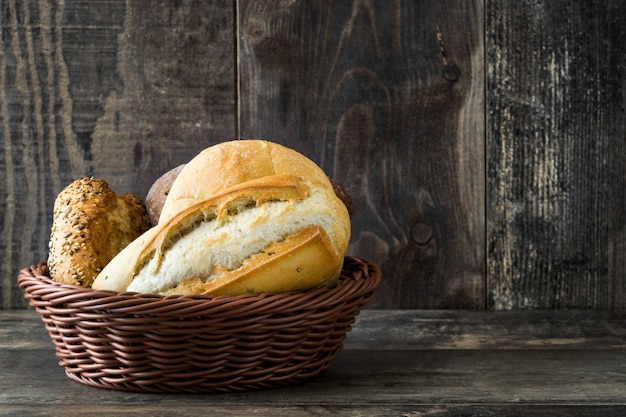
[486,0,626,309]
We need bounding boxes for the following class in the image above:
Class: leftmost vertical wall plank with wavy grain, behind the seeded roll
[0,0,236,309]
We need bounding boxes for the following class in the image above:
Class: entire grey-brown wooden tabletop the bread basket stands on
[0,310,626,417]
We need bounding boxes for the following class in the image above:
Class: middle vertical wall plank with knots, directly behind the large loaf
[238,0,485,308]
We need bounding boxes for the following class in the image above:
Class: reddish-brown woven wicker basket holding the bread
[18,257,381,393]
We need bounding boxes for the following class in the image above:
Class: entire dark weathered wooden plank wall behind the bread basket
[0,0,626,310]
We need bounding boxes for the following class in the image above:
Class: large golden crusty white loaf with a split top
[93,140,350,295]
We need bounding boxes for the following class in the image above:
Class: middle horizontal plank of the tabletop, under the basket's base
[0,350,626,410]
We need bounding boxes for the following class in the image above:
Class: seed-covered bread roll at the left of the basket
[48,178,150,287]
